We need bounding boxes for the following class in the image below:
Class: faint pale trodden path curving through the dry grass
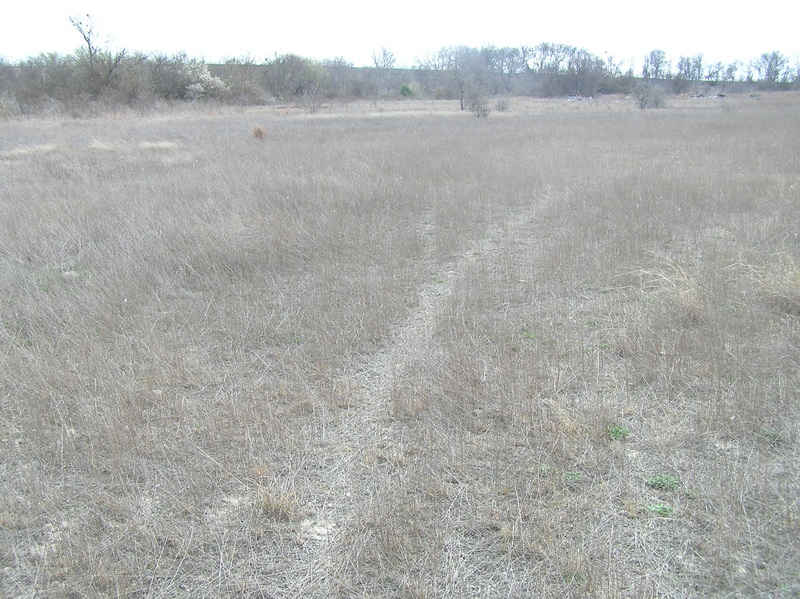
[278,209,533,597]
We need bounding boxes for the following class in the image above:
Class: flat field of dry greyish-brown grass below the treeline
[0,93,800,598]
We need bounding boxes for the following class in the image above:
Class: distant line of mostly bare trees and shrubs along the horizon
[0,33,800,118]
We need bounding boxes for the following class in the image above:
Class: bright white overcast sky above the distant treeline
[0,0,800,68]
